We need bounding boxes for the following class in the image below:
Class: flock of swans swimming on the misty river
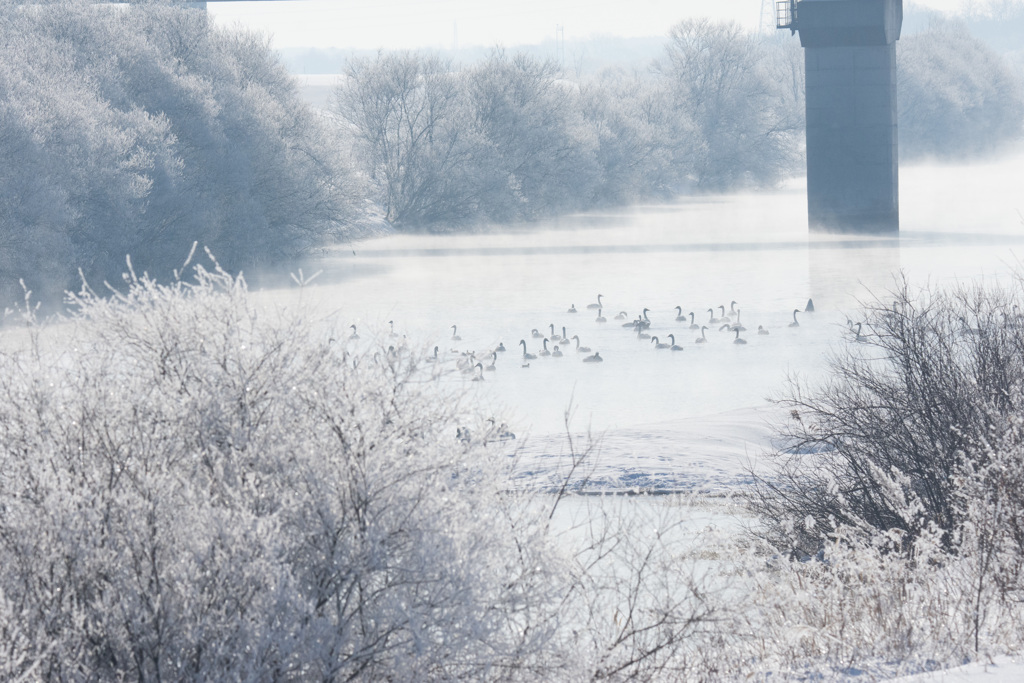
[399,294,814,381]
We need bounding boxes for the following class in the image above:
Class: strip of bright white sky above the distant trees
[208,0,965,49]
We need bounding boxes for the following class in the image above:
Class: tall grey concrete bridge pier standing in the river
[777,0,903,233]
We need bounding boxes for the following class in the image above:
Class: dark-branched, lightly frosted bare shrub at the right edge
[755,274,1024,555]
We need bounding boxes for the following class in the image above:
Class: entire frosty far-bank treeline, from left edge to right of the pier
[0,0,1024,303]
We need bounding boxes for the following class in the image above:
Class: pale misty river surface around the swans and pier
[260,150,1024,487]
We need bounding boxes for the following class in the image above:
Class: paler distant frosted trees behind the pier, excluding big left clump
[336,19,1024,228]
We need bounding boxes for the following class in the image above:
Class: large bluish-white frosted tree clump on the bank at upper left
[0,0,356,301]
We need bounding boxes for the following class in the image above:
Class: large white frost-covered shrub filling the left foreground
[0,254,564,680]
